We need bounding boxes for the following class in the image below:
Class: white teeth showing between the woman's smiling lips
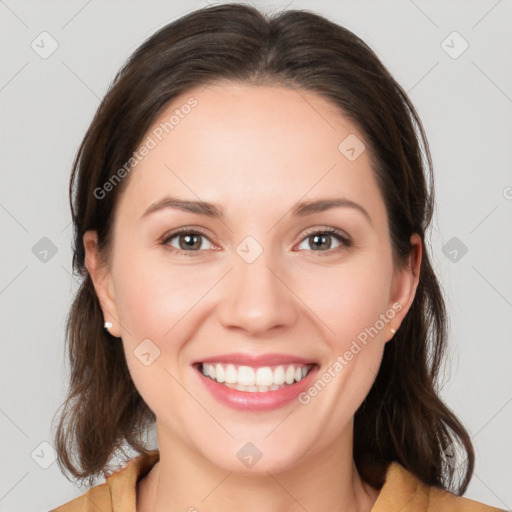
[196,362,316,393]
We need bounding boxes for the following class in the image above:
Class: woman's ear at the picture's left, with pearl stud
[83,231,121,337]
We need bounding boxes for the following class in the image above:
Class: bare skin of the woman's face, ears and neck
[84,82,422,512]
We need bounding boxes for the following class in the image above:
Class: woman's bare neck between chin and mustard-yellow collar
[137,426,379,512]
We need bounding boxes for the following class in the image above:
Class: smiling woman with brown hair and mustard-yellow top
[50,4,497,512]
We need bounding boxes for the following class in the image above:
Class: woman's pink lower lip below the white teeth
[196,365,318,412]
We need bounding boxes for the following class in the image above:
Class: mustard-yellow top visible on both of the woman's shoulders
[50,450,503,512]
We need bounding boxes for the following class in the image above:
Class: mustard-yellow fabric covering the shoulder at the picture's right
[371,462,502,512]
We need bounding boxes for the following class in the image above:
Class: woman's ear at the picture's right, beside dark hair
[386,233,423,341]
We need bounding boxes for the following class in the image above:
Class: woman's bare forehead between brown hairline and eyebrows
[117,82,383,229]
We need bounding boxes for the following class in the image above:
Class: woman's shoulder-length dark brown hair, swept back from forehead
[55,4,474,494]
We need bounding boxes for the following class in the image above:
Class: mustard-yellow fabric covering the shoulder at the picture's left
[50,450,160,512]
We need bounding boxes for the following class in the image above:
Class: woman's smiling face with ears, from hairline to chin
[84,83,421,472]
